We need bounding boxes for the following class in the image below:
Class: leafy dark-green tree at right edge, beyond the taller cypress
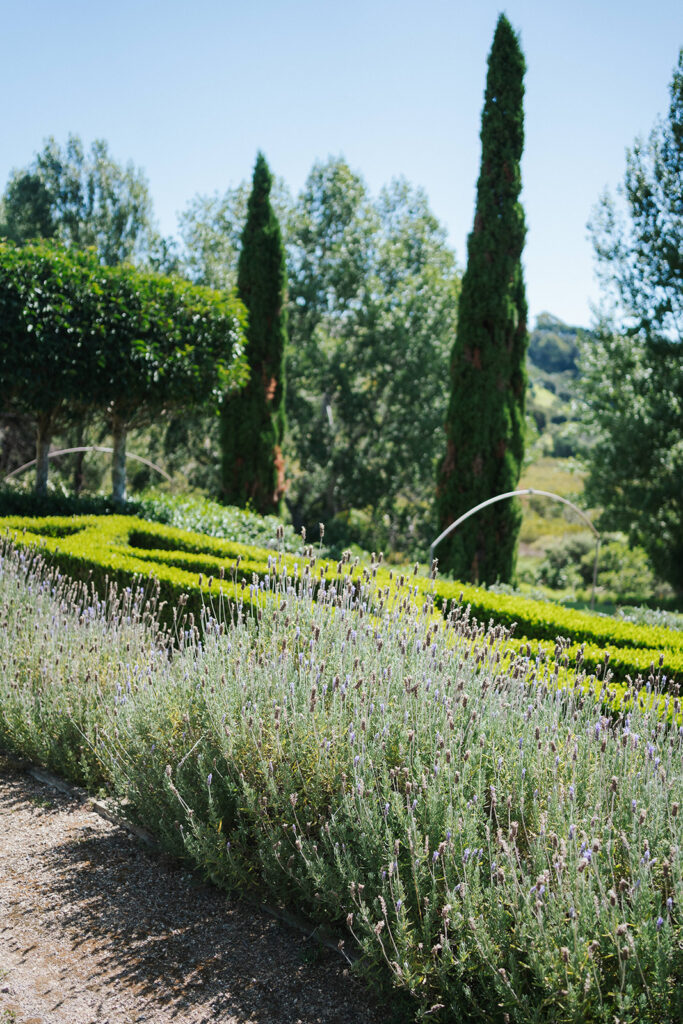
[579,49,683,591]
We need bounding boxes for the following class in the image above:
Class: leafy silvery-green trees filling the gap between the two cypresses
[179,158,459,544]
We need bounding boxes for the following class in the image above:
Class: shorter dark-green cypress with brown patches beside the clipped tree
[221,153,287,515]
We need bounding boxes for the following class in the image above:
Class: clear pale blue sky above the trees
[0,0,683,326]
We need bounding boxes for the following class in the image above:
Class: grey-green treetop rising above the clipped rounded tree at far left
[0,135,159,266]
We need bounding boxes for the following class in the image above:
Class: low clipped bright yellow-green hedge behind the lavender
[0,515,683,682]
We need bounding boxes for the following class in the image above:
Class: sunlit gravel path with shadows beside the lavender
[0,760,386,1024]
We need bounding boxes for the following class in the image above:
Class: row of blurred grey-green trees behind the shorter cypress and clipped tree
[0,137,460,544]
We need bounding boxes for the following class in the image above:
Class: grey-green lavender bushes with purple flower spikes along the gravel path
[0,549,683,1024]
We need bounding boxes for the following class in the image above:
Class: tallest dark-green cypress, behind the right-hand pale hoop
[437,14,527,583]
